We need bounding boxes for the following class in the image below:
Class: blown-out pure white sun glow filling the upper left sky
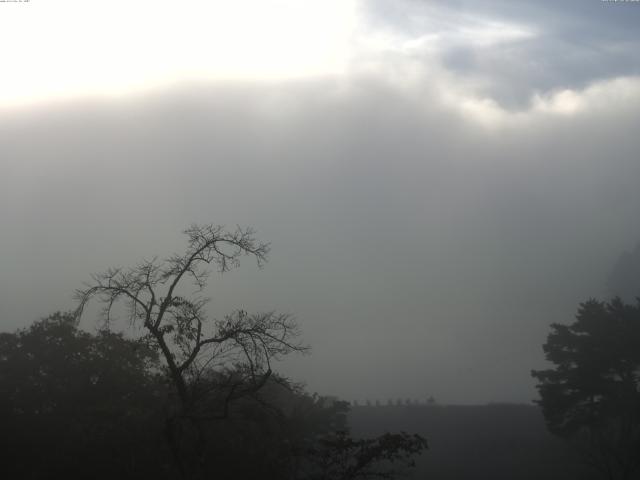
[0,0,356,105]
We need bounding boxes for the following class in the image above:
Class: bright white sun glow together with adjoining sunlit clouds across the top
[0,0,640,129]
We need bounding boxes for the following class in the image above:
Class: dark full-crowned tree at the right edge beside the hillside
[532,298,640,479]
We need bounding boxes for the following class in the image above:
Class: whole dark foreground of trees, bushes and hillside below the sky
[0,225,640,480]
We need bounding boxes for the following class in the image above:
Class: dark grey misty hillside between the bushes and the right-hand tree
[349,404,597,480]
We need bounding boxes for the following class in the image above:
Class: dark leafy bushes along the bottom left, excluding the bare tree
[0,313,426,480]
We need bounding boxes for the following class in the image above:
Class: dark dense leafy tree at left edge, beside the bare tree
[0,313,171,479]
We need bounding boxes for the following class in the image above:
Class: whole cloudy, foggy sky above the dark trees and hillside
[0,0,640,404]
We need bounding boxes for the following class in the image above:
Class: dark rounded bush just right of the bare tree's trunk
[198,376,348,480]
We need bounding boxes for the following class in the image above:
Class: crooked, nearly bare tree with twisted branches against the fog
[76,225,307,476]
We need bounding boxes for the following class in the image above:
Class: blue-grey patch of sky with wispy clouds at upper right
[358,0,640,111]
